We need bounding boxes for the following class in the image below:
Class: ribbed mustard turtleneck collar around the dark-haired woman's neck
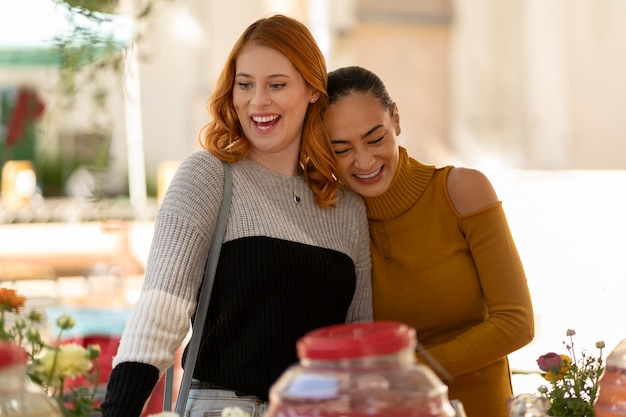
[364,146,435,221]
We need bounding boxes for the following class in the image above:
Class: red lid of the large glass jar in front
[296,321,417,360]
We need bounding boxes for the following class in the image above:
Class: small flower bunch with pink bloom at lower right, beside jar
[537,329,605,417]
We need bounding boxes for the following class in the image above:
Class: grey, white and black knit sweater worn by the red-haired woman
[102,151,372,417]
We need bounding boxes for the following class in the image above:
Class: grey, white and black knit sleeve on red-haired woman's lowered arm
[102,151,224,417]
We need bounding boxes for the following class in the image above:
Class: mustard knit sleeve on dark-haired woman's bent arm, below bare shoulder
[419,203,534,377]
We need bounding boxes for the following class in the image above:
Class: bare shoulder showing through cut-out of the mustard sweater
[447,167,498,214]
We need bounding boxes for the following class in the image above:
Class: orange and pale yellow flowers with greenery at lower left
[0,288,100,417]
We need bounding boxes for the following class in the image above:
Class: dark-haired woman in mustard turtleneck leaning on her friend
[324,67,534,417]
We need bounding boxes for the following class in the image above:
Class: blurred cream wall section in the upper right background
[451,0,626,169]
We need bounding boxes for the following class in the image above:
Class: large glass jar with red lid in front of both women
[267,321,456,417]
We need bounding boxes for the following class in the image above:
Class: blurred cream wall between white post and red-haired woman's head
[133,0,261,185]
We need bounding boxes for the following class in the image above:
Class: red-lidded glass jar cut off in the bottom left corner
[0,341,62,417]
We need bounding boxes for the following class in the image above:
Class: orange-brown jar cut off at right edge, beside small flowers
[594,339,626,417]
